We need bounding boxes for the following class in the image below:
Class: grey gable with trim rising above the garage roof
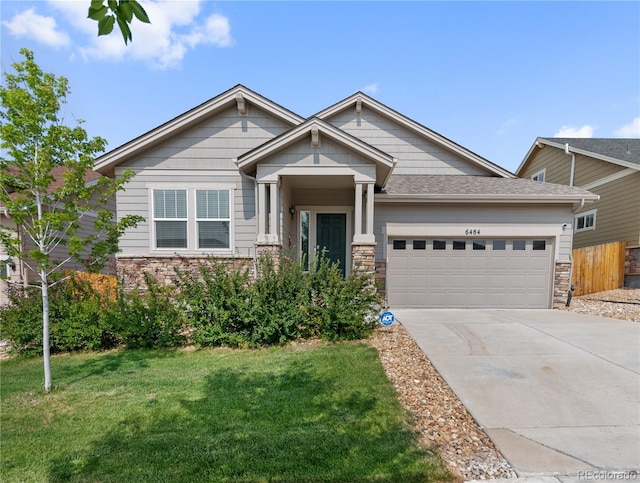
[317,92,514,178]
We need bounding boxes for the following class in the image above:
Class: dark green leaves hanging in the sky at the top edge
[87,0,151,44]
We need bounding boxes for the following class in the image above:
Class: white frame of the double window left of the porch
[146,182,236,256]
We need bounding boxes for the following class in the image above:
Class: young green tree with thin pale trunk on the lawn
[0,49,141,392]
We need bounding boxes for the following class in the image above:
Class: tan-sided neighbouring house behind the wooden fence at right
[516,137,640,286]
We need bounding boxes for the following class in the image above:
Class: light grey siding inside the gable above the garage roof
[327,106,487,176]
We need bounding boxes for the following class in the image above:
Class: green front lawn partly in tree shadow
[0,343,452,482]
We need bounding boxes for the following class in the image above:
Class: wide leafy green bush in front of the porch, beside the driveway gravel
[177,257,379,347]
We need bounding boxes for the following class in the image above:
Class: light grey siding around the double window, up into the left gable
[116,105,290,256]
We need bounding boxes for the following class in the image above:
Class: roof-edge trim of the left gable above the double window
[94,84,304,176]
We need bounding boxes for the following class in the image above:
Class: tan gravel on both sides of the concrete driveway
[369,289,640,480]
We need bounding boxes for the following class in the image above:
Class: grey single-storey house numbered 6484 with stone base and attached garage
[95,85,597,308]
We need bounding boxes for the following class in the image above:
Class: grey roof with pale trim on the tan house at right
[516,137,640,173]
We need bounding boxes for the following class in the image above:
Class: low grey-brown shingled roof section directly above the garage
[376,175,599,203]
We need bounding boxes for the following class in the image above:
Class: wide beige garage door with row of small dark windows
[387,238,553,308]
